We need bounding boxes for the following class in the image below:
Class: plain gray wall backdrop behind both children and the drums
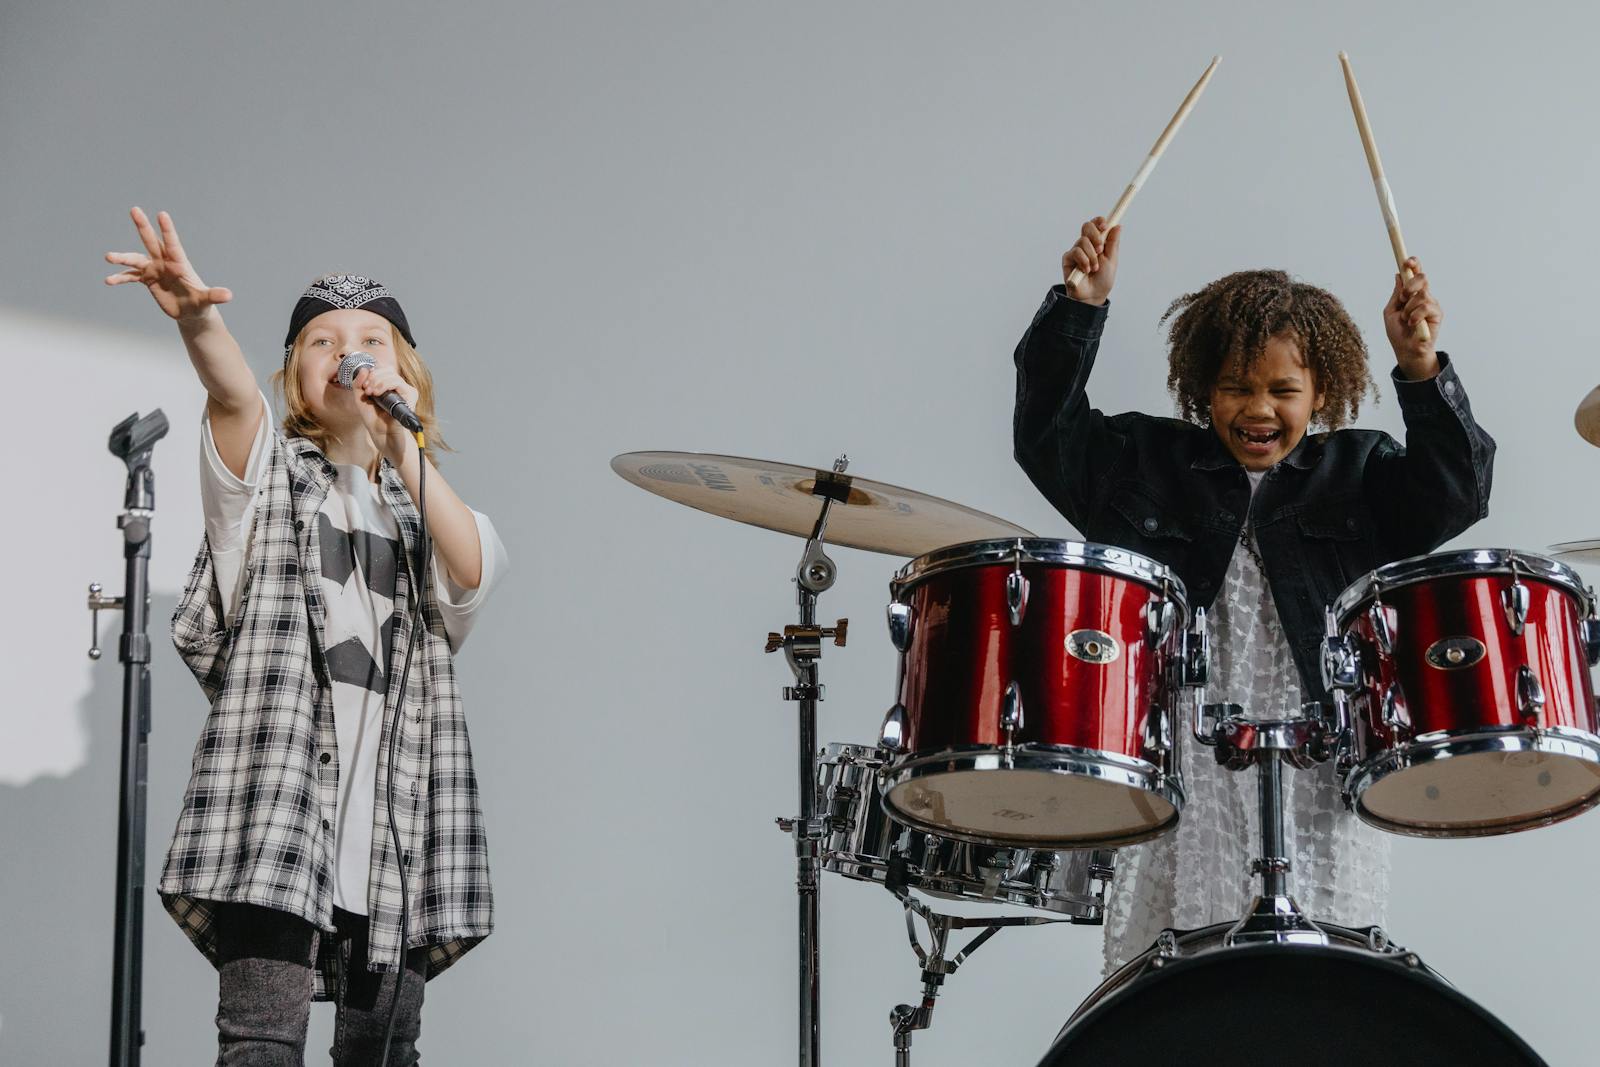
[0,0,1600,1065]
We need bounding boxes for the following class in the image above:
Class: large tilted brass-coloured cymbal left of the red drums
[611,453,1034,555]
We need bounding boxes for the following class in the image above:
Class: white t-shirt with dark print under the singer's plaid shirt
[200,397,506,915]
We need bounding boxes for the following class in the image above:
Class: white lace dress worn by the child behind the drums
[1106,474,1389,974]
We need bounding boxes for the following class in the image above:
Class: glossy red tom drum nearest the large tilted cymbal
[882,539,1187,848]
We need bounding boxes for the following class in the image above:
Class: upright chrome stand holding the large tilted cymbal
[766,456,850,1067]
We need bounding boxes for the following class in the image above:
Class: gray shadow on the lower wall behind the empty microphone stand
[0,598,216,1067]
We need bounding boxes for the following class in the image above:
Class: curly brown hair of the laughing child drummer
[1162,270,1376,430]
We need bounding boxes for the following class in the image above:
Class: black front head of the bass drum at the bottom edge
[1040,945,1544,1067]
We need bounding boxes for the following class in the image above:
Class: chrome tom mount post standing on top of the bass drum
[1194,702,1344,945]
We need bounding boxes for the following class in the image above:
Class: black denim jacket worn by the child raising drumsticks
[1013,285,1494,703]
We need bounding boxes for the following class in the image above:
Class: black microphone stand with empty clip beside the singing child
[88,408,166,1067]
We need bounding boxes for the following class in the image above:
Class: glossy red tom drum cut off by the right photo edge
[1323,549,1600,837]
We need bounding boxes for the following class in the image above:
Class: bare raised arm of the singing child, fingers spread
[106,208,266,477]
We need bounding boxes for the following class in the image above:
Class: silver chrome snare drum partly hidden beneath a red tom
[818,744,1115,923]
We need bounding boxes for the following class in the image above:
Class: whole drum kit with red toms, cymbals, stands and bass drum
[611,398,1600,1067]
